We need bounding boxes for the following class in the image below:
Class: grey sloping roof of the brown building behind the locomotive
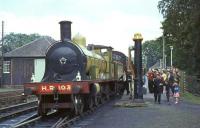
[4,37,56,58]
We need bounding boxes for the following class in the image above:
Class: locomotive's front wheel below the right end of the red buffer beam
[72,95,84,115]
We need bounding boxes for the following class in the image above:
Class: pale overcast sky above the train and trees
[0,0,163,54]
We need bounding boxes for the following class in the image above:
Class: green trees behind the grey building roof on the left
[3,33,41,53]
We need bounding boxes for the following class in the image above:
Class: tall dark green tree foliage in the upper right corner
[158,0,200,74]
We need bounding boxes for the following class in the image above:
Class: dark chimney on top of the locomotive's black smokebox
[59,21,72,42]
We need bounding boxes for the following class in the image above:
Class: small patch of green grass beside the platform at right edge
[182,92,200,104]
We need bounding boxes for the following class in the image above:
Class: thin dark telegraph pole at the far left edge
[1,21,4,87]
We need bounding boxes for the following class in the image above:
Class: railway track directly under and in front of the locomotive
[13,98,114,128]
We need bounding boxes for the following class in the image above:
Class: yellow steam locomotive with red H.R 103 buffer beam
[24,21,127,115]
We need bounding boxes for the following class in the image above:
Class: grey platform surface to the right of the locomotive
[73,94,200,128]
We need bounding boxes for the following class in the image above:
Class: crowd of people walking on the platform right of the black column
[147,69,180,104]
